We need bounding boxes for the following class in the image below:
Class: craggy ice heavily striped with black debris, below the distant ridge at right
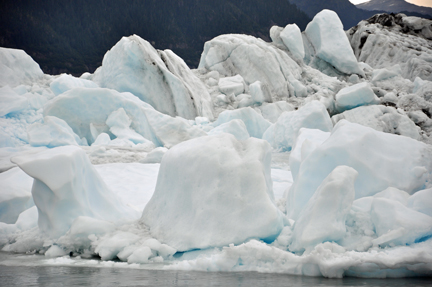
[347,14,432,81]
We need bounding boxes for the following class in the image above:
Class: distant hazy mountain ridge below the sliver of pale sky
[356,0,432,17]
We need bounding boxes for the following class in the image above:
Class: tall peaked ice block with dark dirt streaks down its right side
[93,35,212,119]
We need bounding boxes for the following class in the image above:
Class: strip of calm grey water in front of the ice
[0,266,432,287]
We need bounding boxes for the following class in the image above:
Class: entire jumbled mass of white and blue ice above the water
[0,10,432,278]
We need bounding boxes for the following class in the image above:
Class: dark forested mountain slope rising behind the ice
[0,0,310,74]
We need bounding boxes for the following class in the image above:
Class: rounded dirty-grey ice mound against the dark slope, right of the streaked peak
[198,34,301,98]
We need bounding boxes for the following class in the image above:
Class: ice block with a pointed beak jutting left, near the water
[12,146,138,237]
